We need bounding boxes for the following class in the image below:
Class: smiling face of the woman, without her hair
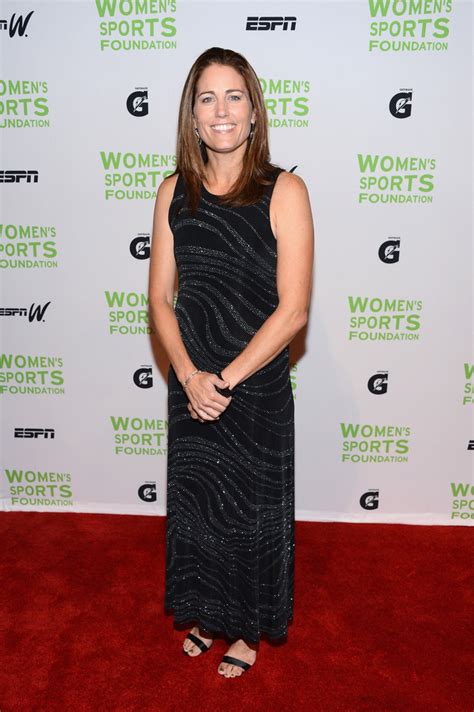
[193,64,255,153]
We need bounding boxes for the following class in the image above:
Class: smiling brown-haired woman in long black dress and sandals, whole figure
[149,47,313,677]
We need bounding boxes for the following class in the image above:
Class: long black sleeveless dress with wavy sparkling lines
[165,169,294,643]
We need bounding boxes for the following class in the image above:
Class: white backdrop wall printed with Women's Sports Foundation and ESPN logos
[0,0,474,525]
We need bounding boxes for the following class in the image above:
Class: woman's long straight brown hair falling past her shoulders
[174,47,276,212]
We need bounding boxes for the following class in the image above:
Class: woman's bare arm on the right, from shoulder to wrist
[222,172,314,388]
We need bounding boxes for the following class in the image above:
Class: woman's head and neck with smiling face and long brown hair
[170,47,282,212]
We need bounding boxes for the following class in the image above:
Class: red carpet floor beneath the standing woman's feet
[0,512,474,712]
